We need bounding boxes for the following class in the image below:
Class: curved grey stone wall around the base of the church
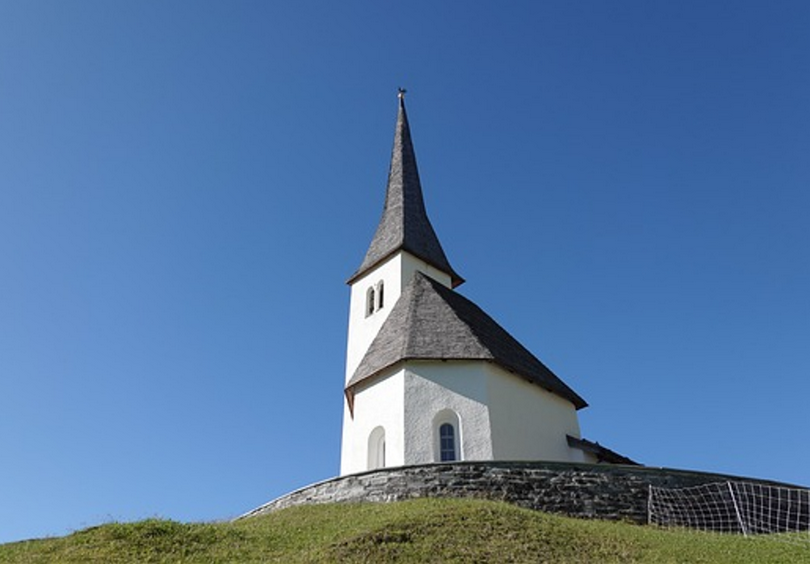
[238,462,795,523]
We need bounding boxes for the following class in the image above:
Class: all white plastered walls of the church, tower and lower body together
[340,245,585,475]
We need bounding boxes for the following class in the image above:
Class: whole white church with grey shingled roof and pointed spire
[340,90,634,476]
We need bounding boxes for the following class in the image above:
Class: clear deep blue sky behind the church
[0,0,810,542]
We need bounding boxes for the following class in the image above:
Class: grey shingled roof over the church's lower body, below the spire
[346,272,588,409]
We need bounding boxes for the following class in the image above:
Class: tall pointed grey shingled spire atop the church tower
[349,93,464,287]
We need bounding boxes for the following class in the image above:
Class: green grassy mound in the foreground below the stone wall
[0,499,810,564]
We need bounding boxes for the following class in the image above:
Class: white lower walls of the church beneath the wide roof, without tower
[341,352,586,475]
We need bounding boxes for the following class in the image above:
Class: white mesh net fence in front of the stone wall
[647,482,810,542]
